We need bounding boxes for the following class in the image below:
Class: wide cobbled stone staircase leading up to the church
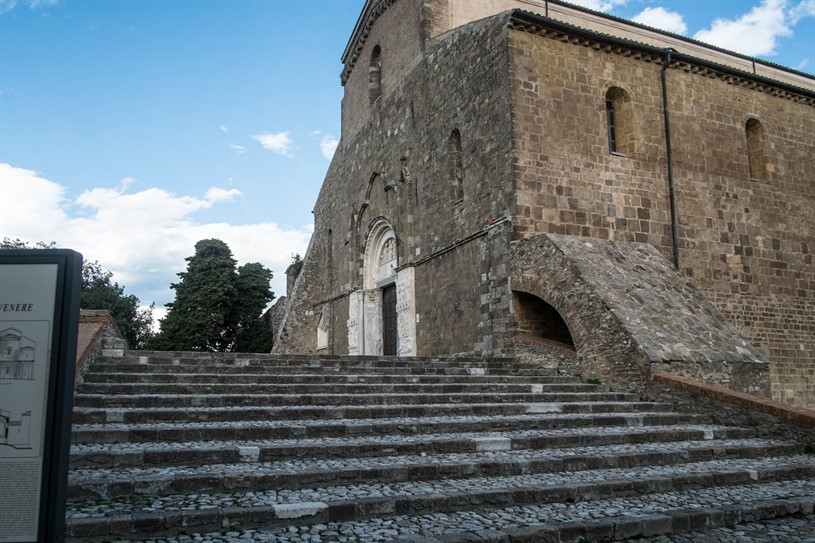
[67,352,815,543]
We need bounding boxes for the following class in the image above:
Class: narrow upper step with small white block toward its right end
[73,383,598,397]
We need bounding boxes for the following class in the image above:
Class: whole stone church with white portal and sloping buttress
[275,0,815,407]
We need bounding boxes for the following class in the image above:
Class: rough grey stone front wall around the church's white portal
[275,12,514,355]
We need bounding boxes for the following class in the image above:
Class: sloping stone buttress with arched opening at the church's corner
[512,234,769,394]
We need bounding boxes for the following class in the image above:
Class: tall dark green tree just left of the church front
[150,239,274,352]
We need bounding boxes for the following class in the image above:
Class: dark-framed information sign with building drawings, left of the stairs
[0,249,82,543]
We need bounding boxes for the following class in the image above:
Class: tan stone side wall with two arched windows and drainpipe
[509,19,815,405]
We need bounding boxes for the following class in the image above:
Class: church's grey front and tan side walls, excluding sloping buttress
[278,0,815,405]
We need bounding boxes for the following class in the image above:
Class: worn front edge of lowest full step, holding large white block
[67,468,815,536]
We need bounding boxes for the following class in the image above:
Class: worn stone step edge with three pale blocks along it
[70,426,756,468]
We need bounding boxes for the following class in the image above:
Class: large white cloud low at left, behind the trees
[0,163,313,307]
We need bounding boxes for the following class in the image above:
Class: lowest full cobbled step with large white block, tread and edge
[63,456,815,536]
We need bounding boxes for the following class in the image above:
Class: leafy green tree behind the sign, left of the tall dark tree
[0,238,153,349]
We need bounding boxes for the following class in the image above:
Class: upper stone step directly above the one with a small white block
[83,371,580,385]
